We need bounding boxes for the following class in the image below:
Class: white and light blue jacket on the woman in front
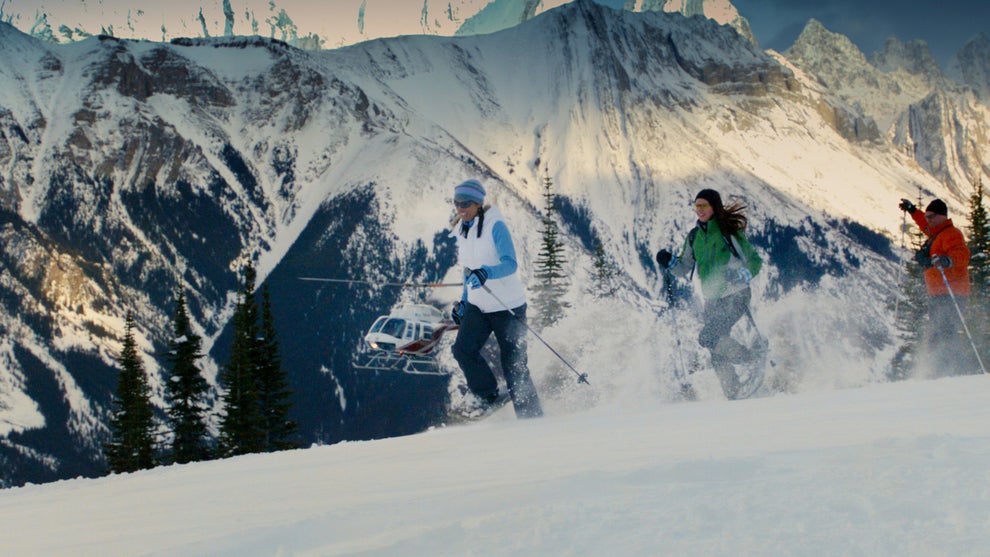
[450,207,526,313]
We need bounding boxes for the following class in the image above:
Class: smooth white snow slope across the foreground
[0,377,990,557]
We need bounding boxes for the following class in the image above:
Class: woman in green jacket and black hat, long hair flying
[657,189,763,399]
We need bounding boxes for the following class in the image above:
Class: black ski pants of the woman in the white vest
[452,304,543,418]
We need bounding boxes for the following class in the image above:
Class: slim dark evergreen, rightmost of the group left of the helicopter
[258,283,297,451]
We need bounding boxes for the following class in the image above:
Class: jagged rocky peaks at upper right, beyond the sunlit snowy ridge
[785,21,990,193]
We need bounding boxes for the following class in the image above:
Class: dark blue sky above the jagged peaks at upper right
[731,0,990,68]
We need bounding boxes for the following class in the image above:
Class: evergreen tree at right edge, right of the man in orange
[966,181,990,362]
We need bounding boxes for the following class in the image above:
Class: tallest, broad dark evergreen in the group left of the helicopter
[220,264,265,456]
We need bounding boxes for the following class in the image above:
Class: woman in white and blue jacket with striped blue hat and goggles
[451,180,543,418]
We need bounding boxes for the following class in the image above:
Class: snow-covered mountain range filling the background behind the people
[0,0,990,485]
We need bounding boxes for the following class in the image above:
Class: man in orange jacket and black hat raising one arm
[899,199,972,375]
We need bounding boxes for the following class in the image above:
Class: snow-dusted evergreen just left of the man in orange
[890,217,928,379]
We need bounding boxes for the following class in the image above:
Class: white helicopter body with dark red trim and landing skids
[354,304,459,375]
